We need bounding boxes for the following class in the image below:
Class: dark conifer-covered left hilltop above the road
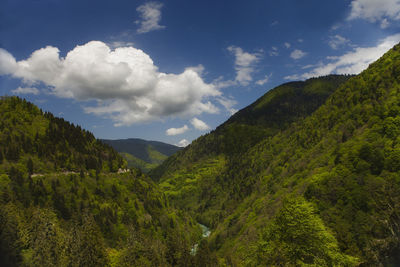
[0,96,123,174]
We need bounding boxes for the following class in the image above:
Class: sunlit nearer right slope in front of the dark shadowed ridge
[212,45,400,266]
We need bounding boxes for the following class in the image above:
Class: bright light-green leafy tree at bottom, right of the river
[256,199,358,266]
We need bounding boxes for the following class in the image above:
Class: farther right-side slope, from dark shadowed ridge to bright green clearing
[150,75,349,230]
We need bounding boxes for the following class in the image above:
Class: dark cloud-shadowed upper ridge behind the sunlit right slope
[150,75,350,183]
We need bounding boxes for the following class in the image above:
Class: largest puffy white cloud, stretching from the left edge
[0,41,221,126]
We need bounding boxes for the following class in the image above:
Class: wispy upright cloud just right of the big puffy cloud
[228,46,261,85]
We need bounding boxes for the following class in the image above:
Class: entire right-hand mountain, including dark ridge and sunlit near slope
[151,45,400,266]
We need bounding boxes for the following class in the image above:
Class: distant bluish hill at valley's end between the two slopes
[101,138,181,172]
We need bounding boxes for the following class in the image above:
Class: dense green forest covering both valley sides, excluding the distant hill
[0,42,400,266]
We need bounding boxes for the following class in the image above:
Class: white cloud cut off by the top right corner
[348,0,400,28]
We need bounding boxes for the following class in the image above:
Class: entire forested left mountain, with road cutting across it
[0,97,201,266]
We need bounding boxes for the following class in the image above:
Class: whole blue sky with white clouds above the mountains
[0,0,400,146]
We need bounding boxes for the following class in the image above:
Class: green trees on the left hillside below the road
[0,171,200,266]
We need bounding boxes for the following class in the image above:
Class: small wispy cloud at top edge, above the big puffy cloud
[136,2,165,33]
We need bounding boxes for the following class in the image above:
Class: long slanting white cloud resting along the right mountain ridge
[285,34,400,80]
